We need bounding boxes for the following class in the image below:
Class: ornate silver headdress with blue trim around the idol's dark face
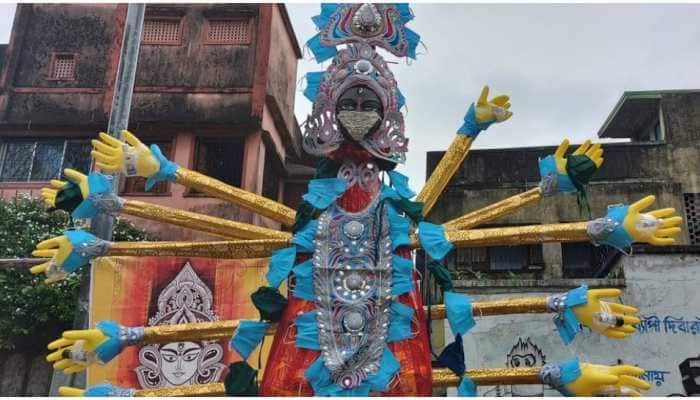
[303,4,420,163]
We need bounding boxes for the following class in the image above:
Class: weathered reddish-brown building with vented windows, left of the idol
[0,4,301,239]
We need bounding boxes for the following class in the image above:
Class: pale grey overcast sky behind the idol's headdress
[0,3,700,189]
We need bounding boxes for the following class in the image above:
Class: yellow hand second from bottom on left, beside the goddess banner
[46,329,108,374]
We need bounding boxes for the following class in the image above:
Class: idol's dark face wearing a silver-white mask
[336,86,384,142]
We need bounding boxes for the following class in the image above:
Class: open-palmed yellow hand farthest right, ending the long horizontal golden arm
[622,196,683,246]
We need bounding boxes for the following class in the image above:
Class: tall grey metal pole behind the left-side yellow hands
[49,3,146,396]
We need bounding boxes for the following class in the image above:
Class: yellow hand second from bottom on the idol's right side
[572,289,641,339]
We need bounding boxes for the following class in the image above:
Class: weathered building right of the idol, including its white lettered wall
[428,90,700,395]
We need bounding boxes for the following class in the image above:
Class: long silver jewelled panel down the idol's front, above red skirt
[313,196,392,389]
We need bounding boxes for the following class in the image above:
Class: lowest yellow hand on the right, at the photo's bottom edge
[566,363,651,397]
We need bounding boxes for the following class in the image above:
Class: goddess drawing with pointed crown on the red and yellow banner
[135,262,225,389]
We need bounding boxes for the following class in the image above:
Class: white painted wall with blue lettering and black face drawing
[446,254,700,396]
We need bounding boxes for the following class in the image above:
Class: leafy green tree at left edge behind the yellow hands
[0,195,151,350]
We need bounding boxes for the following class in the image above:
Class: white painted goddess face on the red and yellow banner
[158,342,202,386]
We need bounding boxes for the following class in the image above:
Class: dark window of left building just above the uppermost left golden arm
[190,137,243,194]
